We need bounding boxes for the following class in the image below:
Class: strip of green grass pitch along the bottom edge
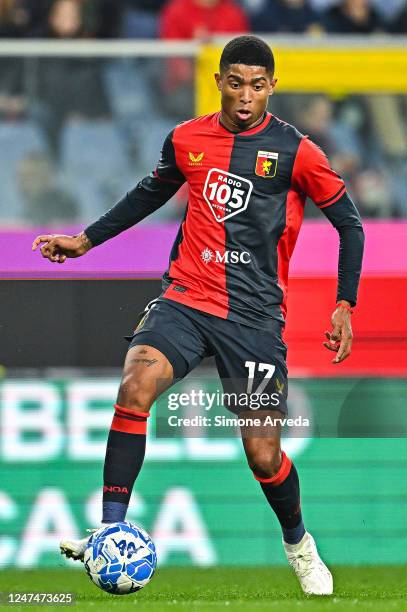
[0,566,407,612]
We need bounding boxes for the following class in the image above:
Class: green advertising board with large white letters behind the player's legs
[0,372,407,568]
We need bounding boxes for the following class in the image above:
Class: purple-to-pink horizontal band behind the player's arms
[0,222,407,279]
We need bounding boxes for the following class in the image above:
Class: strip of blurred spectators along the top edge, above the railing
[0,0,407,39]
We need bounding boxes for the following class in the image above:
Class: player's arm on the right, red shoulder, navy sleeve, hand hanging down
[293,138,364,363]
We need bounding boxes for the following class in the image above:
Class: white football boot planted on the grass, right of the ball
[283,531,333,595]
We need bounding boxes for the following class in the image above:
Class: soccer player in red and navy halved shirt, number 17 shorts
[33,36,364,595]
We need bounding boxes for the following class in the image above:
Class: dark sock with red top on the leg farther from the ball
[254,451,305,544]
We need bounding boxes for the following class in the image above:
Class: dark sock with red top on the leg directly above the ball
[102,404,148,523]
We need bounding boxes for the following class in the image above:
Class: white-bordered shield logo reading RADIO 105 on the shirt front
[203,168,253,223]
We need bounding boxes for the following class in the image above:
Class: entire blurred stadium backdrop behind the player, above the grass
[0,0,407,568]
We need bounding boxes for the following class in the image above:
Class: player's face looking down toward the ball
[215,64,277,132]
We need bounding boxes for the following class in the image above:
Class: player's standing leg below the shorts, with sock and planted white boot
[239,411,333,595]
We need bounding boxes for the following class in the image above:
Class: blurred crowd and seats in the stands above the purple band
[0,0,407,224]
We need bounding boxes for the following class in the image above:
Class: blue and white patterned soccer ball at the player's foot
[83,521,157,595]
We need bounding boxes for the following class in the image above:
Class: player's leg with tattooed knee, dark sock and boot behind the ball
[60,345,173,560]
